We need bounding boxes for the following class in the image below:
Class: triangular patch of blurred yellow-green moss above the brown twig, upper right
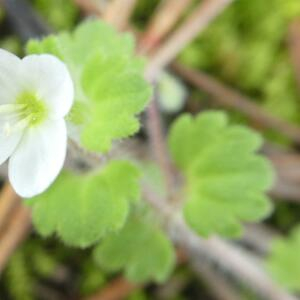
[180,0,300,127]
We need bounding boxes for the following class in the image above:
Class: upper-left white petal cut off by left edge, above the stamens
[0,49,21,104]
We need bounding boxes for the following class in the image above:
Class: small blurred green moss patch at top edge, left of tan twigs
[33,0,79,30]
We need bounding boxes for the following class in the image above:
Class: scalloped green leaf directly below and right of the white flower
[30,161,140,247]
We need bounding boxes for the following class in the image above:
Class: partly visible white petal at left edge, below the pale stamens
[0,121,23,165]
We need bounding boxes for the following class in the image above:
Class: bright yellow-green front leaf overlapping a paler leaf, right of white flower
[82,54,149,150]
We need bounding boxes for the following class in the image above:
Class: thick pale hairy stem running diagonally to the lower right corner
[144,189,297,300]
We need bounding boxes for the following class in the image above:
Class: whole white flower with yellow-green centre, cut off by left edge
[0,49,74,197]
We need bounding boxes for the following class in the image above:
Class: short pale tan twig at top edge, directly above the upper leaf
[103,0,137,30]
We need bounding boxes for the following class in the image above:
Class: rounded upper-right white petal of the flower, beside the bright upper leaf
[22,54,74,118]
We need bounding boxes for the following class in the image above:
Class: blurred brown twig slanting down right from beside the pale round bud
[173,64,300,144]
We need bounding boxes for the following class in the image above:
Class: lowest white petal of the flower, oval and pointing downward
[8,119,67,198]
